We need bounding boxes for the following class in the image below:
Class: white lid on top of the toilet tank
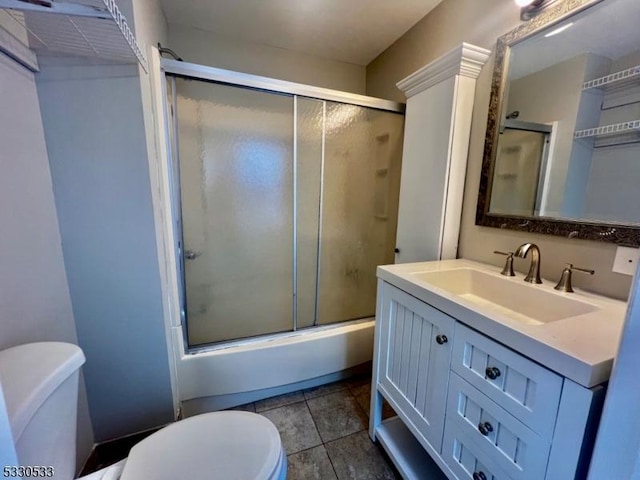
[0,342,85,442]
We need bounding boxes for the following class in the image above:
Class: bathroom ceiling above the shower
[161,0,442,65]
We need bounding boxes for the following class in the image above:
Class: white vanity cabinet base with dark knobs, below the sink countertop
[370,280,604,480]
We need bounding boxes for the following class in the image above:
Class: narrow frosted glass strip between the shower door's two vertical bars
[296,97,324,328]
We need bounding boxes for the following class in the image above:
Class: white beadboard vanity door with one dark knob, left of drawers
[377,283,455,452]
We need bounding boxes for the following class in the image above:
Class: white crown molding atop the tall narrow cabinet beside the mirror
[396,42,491,98]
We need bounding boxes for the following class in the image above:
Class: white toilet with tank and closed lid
[0,342,287,480]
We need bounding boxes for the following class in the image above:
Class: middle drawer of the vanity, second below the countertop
[447,373,551,480]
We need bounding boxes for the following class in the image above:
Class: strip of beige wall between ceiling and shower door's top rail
[163,20,365,94]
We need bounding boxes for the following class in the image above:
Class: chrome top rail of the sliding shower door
[162,58,405,113]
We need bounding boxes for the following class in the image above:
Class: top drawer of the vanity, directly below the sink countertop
[451,323,562,441]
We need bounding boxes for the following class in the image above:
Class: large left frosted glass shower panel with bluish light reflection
[177,79,293,345]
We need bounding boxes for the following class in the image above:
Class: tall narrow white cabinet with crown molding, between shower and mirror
[396,43,490,263]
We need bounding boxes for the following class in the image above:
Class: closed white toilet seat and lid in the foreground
[120,411,286,480]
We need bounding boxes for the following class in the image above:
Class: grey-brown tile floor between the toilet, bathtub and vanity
[234,377,400,480]
